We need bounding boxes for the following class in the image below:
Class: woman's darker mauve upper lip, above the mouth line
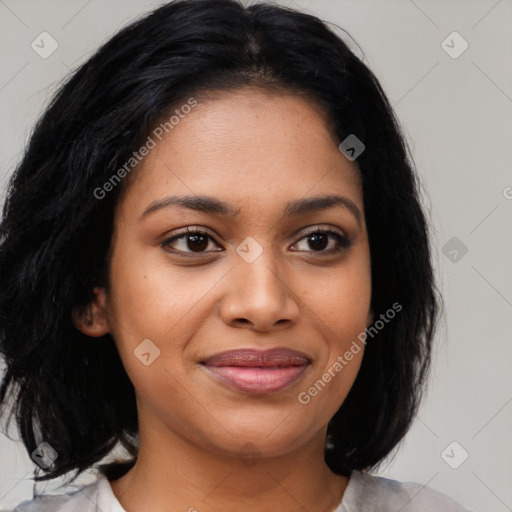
[201,347,311,367]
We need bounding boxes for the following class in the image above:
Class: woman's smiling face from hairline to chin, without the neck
[91,89,371,456]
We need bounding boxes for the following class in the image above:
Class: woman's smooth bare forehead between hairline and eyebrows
[119,88,362,214]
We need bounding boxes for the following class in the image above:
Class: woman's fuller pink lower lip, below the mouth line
[204,365,307,393]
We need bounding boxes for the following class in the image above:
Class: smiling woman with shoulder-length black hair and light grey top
[0,0,467,512]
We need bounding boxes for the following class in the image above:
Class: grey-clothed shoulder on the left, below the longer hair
[6,483,97,512]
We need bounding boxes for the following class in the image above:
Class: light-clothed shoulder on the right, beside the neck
[341,471,472,512]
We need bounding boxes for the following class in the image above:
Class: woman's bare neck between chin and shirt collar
[111,406,348,512]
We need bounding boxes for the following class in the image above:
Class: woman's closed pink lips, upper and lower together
[201,348,311,394]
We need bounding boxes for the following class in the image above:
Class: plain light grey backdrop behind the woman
[0,0,512,512]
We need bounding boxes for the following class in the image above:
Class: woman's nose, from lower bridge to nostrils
[220,251,300,331]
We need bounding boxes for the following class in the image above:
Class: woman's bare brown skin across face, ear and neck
[75,88,372,512]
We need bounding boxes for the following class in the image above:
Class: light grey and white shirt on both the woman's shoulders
[6,471,472,512]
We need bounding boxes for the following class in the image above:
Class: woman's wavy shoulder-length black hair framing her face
[0,0,441,480]
